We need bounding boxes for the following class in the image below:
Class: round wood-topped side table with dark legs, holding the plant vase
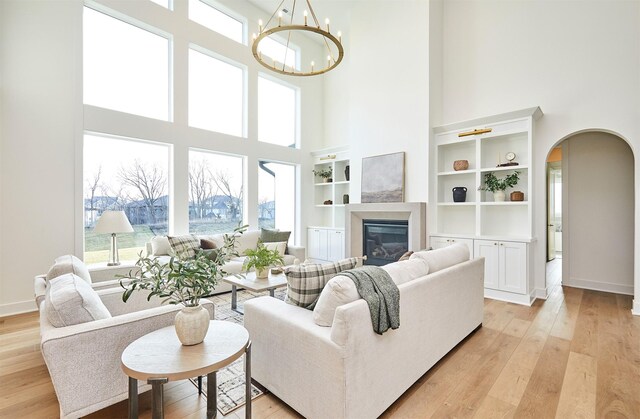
[122,320,251,419]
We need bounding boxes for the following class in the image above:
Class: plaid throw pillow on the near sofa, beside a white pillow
[284,258,358,310]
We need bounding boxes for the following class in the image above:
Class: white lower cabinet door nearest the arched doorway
[499,242,527,294]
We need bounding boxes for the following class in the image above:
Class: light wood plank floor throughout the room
[0,285,640,419]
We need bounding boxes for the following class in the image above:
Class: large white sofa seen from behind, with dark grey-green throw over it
[244,246,484,419]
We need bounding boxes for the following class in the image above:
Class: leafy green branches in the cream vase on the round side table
[120,226,248,307]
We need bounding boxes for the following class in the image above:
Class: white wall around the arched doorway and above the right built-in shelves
[442,0,640,314]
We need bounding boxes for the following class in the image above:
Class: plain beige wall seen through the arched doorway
[562,132,635,294]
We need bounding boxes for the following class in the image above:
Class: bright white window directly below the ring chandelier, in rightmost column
[258,76,297,148]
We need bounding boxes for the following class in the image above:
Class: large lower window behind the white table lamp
[83,134,169,263]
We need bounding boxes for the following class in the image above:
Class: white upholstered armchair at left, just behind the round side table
[34,276,214,418]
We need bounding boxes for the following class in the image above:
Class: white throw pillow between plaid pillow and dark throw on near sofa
[313,275,360,326]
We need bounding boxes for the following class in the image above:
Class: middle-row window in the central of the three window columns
[189,49,244,137]
